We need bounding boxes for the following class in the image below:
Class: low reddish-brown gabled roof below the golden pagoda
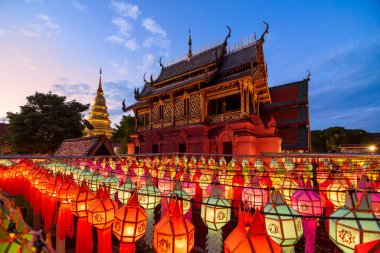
[54,135,115,156]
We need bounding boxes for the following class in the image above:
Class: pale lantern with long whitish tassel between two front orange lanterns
[138,177,161,248]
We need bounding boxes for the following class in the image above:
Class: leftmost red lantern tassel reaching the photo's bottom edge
[75,217,93,253]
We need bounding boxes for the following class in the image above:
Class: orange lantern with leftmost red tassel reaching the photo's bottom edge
[70,182,95,252]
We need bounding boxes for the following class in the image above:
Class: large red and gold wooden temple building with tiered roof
[123,23,310,155]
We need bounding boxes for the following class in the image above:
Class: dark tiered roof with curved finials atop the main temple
[124,23,270,107]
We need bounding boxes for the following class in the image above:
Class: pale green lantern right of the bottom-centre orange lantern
[264,190,303,251]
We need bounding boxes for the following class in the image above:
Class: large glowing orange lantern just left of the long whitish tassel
[112,190,147,252]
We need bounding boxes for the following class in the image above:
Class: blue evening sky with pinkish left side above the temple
[0,0,380,132]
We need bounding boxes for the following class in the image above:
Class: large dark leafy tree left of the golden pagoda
[7,92,89,154]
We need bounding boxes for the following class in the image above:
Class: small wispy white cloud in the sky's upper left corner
[22,14,61,37]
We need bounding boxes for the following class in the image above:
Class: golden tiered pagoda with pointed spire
[85,69,112,137]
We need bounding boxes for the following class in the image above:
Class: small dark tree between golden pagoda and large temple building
[112,115,135,154]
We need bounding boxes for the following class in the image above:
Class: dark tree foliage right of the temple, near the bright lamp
[311,127,376,153]
